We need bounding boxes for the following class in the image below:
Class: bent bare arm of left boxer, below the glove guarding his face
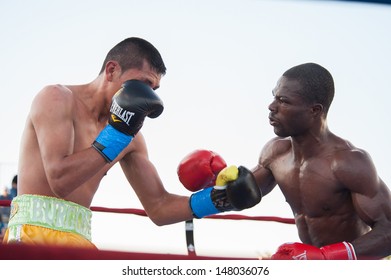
[30,86,106,197]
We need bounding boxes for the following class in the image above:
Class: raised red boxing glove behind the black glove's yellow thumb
[177,150,227,192]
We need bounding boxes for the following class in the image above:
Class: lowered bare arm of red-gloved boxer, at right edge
[334,149,391,259]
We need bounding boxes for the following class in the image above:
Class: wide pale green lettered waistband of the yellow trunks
[8,194,92,240]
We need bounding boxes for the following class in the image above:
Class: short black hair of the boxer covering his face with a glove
[99,37,167,75]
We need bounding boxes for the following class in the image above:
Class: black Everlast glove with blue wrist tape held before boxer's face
[92,80,164,162]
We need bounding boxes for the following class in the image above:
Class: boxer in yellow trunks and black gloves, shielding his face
[6,37,260,249]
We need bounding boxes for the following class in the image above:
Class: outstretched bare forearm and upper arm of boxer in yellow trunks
[120,133,193,225]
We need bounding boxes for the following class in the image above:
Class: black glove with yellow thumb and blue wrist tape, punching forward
[189,166,262,218]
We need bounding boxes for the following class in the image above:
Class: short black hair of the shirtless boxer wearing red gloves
[283,63,335,115]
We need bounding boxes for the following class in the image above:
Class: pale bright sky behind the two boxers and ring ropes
[0,0,391,257]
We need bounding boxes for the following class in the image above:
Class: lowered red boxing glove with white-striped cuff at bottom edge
[271,241,357,260]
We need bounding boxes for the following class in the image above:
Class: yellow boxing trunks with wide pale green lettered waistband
[4,194,96,248]
